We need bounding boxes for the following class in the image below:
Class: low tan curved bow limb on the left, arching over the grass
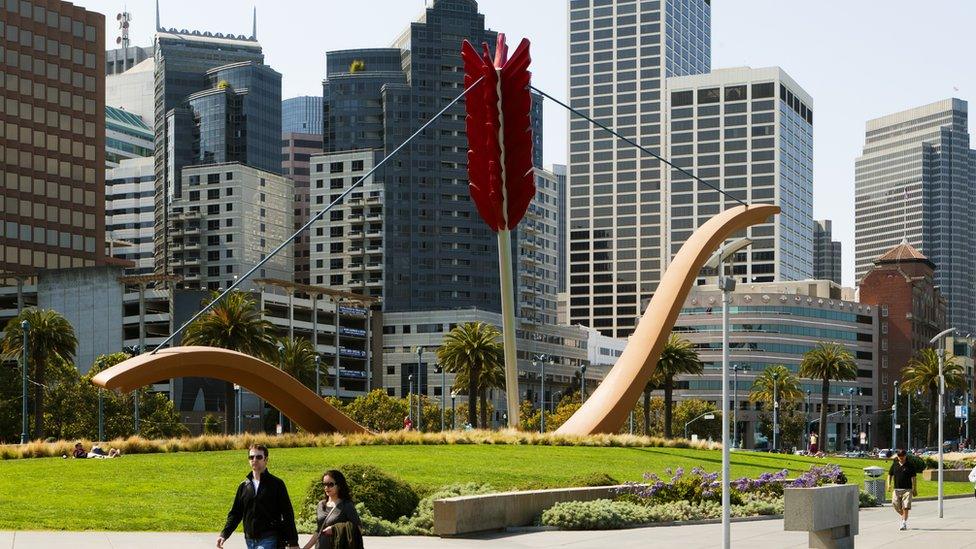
[92,347,368,434]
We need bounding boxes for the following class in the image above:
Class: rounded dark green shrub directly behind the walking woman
[298,465,419,524]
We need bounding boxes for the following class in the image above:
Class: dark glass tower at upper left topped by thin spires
[153,20,266,273]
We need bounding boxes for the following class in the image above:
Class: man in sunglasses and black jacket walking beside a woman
[217,444,298,549]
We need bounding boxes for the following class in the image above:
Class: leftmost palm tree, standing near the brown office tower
[0,307,78,438]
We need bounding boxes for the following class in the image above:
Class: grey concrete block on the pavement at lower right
[783,484,858,549]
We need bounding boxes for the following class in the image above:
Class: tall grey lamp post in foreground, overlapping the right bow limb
[705,238,752,549]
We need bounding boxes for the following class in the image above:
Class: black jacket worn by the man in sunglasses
[220,470,298,546]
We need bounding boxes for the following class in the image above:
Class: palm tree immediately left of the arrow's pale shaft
[437,322,505,425]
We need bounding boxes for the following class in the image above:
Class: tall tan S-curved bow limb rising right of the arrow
[556,205,779,435]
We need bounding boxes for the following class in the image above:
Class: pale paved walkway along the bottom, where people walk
[0,498,976,549]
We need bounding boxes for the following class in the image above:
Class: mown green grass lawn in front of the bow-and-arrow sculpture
[0,445,972,532]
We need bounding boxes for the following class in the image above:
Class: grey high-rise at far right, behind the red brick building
[854,99,976,332]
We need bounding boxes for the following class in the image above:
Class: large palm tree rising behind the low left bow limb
[183,291,277,433]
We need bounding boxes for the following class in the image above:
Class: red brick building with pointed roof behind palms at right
[860,241,946,412]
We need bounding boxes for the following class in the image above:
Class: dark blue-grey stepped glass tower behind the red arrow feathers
[322,0,542,311]
